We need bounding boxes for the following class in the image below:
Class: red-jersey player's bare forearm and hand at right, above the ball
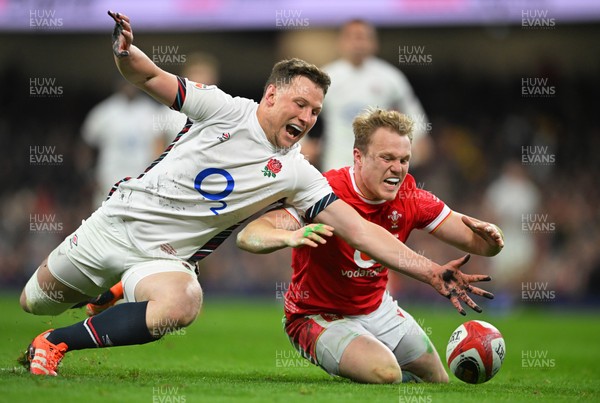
[433,211,504,256]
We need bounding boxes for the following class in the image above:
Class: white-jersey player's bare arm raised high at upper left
[108,11,178,106]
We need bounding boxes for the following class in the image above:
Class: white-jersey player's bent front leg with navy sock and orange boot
[22,258,202,376]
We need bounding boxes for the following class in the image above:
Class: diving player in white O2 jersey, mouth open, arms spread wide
[20,13,487,375]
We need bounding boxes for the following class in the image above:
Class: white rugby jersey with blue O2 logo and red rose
[101,78,335,259]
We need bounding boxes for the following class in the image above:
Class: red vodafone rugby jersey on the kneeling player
[285,167,451,318]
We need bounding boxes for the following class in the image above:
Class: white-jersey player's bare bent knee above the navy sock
[135,272,202,337]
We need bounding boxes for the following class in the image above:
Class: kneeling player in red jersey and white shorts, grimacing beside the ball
[238,109,504,383]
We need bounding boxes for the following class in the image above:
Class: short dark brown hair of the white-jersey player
[264,58,331,95]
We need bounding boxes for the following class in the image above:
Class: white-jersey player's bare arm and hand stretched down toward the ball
[315,200,493,315]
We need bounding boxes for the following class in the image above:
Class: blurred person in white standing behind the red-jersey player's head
[302,20,431,171]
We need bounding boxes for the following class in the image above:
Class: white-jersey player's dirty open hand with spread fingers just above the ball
[431,255,494,315]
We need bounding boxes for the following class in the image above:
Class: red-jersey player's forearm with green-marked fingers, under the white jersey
[237,209,333,253]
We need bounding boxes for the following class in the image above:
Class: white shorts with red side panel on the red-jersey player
[284,291,432,375]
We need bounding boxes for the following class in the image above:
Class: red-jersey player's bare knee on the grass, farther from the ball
[339,335,402,383]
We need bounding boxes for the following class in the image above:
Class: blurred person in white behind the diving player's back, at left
[81,80,165,209]
